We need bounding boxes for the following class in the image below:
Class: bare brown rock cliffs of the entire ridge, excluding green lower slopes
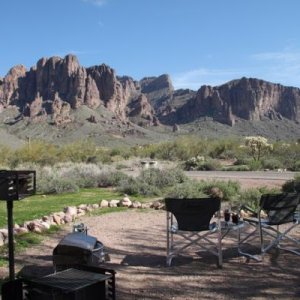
[0,55,300,135]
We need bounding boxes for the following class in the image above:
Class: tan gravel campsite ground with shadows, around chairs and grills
[2,210,300,300]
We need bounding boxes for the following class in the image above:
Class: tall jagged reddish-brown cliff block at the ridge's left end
[0,55,138,124]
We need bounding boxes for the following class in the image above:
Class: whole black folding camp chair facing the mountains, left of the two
[165,198,222,267]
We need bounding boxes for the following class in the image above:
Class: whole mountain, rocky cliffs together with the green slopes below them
[0,55,300,148]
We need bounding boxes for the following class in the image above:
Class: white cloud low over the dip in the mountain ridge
[172,68,243,90]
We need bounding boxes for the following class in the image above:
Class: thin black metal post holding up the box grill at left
[6,200,15,280]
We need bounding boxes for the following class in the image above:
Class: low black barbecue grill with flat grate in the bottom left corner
[1,265,116,300]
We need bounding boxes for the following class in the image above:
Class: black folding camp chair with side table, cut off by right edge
[238,193,300,261]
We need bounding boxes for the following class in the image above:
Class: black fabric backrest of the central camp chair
[165,198,221,231]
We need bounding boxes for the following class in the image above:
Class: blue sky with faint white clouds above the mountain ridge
[0,0,300,90]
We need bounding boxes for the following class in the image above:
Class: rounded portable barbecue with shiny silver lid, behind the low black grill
[53,232,109,271]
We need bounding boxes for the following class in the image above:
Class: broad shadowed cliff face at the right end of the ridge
[176,78,300,125]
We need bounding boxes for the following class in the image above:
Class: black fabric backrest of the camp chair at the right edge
[260,193,300,225]
